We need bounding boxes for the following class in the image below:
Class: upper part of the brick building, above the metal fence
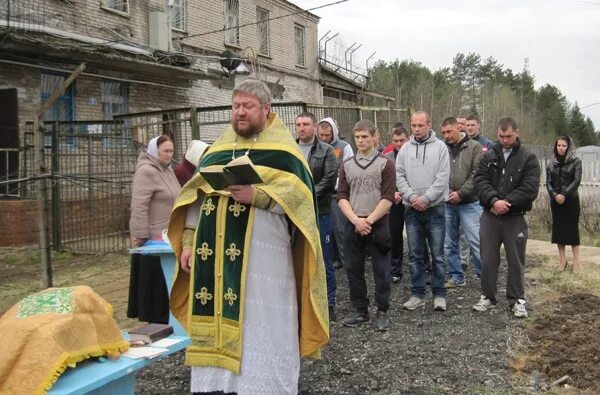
[0,0,322,147]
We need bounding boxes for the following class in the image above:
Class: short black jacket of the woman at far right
[546,156,581,200]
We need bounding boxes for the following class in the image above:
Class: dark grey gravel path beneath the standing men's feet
[136,263,525,394]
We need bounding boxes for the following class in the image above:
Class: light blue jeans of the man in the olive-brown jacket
[444,202,483,282]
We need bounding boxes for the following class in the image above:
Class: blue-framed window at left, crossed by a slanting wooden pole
[40,73,74,147]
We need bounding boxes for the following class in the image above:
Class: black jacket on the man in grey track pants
[475,139,540,215]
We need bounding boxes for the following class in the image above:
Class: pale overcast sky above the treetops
[291,0,600,130]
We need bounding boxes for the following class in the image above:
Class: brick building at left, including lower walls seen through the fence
[0,0,322,245]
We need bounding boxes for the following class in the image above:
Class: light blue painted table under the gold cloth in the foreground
[48,335,191,395]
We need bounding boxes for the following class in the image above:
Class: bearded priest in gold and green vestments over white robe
[169,79,329,394]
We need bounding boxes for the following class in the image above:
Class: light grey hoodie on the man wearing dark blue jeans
[396,130,450,207]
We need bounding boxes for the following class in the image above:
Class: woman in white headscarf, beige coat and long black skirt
[127,134,180,324]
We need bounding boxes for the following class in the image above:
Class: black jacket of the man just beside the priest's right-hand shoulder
[296,136,337,215]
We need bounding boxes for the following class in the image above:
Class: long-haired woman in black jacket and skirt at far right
[546,136,581,273]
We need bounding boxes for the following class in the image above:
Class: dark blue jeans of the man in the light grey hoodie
[404,203,446,298]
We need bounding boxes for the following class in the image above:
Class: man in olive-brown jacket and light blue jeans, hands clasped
[442,117,483,288]
